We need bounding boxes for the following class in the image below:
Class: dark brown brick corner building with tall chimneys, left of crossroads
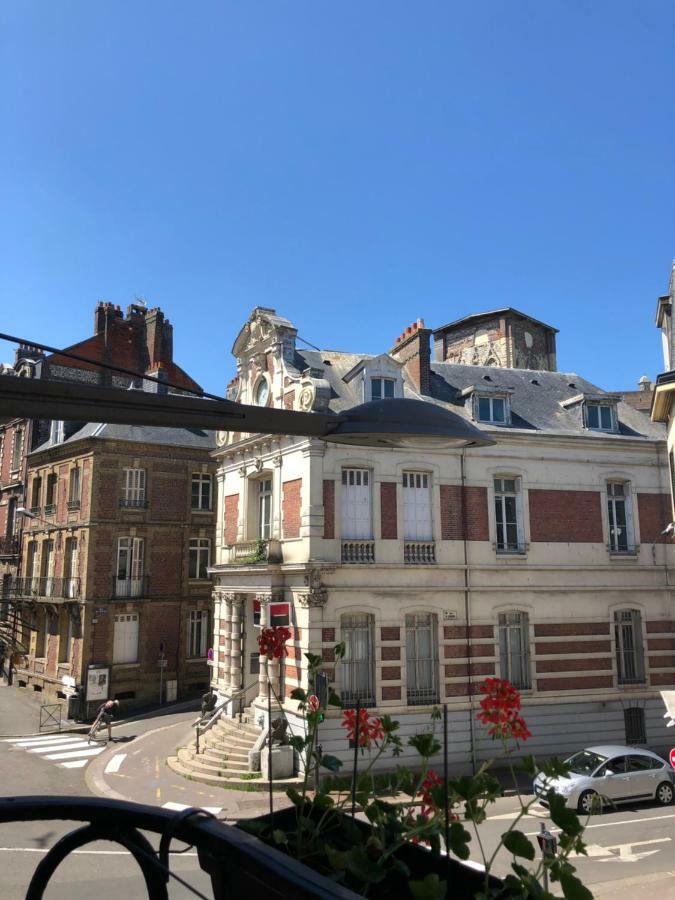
[3,303,214,712]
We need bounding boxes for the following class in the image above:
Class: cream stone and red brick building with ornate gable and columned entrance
[207,308,675,766]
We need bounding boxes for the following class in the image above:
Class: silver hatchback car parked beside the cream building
[533,745,675,813]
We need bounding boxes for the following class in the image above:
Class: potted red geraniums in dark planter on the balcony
[239,629,592,900]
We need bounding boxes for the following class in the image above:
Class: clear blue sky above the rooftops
[0,0,675,392]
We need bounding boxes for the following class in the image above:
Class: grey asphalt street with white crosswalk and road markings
[0,687,675,900]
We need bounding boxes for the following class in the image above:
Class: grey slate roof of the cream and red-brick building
[296,350,665,440]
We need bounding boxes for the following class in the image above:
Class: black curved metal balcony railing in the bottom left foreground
[0,797,357,900]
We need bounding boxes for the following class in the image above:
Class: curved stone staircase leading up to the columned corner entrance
[166,712,301,791]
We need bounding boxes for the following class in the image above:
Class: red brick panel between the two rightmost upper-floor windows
[529,489,604,544]
